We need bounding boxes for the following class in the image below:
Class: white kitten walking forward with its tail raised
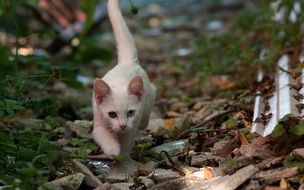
[92,0,156,156]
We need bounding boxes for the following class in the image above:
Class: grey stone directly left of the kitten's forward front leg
[66,120,93,139]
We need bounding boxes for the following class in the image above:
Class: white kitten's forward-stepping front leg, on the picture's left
[93,121,120,156]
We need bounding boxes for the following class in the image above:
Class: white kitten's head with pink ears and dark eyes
[94,76,144,132]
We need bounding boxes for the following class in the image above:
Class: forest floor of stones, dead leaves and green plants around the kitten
[0,0,304,190]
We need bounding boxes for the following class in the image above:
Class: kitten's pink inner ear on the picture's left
[94,79,111,104]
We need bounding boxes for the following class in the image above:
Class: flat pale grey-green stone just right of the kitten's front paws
[149,139,188,160]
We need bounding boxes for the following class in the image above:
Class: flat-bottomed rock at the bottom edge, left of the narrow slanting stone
[45,173,85,190]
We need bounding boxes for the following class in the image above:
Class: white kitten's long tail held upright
[108,0,138,64]
